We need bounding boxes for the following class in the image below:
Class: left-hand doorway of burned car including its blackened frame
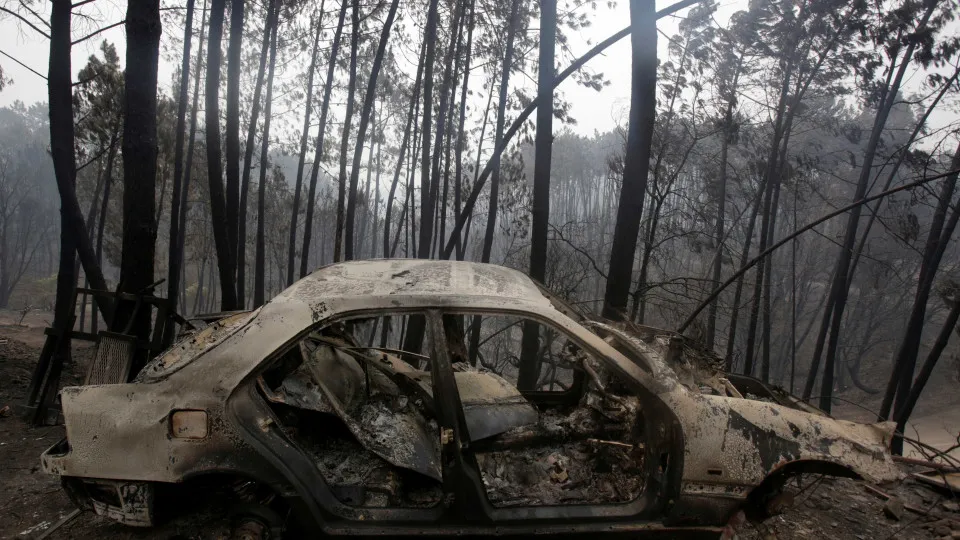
[228,310,462,534]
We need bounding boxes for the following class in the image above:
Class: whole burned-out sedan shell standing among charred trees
[41,260,899,538]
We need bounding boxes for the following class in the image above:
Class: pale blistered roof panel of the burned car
[275,259,549,305]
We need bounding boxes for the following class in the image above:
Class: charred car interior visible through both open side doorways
[257,312,652,508]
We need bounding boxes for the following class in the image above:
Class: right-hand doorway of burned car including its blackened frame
[435,310,682,522]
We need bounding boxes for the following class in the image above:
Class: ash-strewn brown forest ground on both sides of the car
[0,311,960,540]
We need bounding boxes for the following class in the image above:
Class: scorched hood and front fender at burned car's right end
[588,322,902,485]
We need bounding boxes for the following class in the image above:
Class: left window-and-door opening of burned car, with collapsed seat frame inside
[259,315,442,508]
